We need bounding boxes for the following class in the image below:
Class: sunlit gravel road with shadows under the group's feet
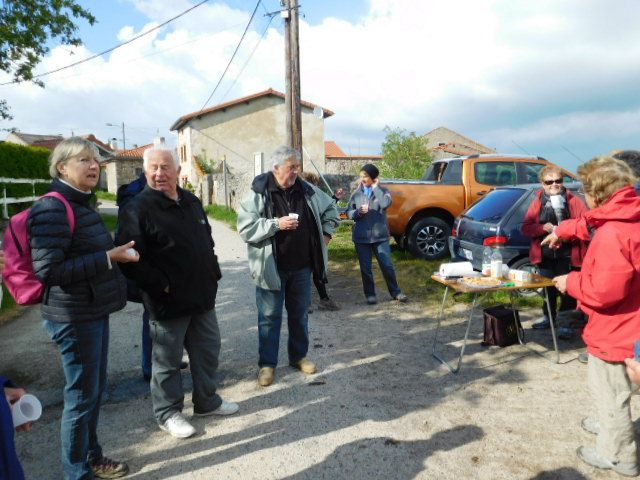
[0,221,624,480]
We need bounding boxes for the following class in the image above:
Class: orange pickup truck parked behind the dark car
[381,154,576,260]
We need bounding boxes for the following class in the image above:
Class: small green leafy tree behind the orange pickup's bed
[379,126,433,179]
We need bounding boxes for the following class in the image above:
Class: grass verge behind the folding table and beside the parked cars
[329,224,542,308]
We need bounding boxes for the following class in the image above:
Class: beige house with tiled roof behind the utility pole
[171,89,333,209]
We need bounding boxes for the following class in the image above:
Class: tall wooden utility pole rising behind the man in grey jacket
[281,0,302,169]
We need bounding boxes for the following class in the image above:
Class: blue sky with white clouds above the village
[0,0,640,170]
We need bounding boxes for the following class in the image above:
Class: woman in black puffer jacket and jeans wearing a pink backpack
[28,137,138,480]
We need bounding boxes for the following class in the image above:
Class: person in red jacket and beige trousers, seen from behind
[542,157,640,476]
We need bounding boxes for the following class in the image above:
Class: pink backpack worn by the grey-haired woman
[2,192,76,305]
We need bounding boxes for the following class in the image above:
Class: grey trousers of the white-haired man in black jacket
[150,309,222,424]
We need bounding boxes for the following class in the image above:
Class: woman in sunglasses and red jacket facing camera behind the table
[522,165,587,329]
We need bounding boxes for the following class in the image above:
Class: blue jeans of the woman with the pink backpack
[44,317,109,480]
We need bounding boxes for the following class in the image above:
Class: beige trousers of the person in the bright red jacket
[587,355,638,463]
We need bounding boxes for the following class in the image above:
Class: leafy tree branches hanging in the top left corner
[0,0,96,119]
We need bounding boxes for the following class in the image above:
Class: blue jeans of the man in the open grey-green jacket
[256,268,311,368]
